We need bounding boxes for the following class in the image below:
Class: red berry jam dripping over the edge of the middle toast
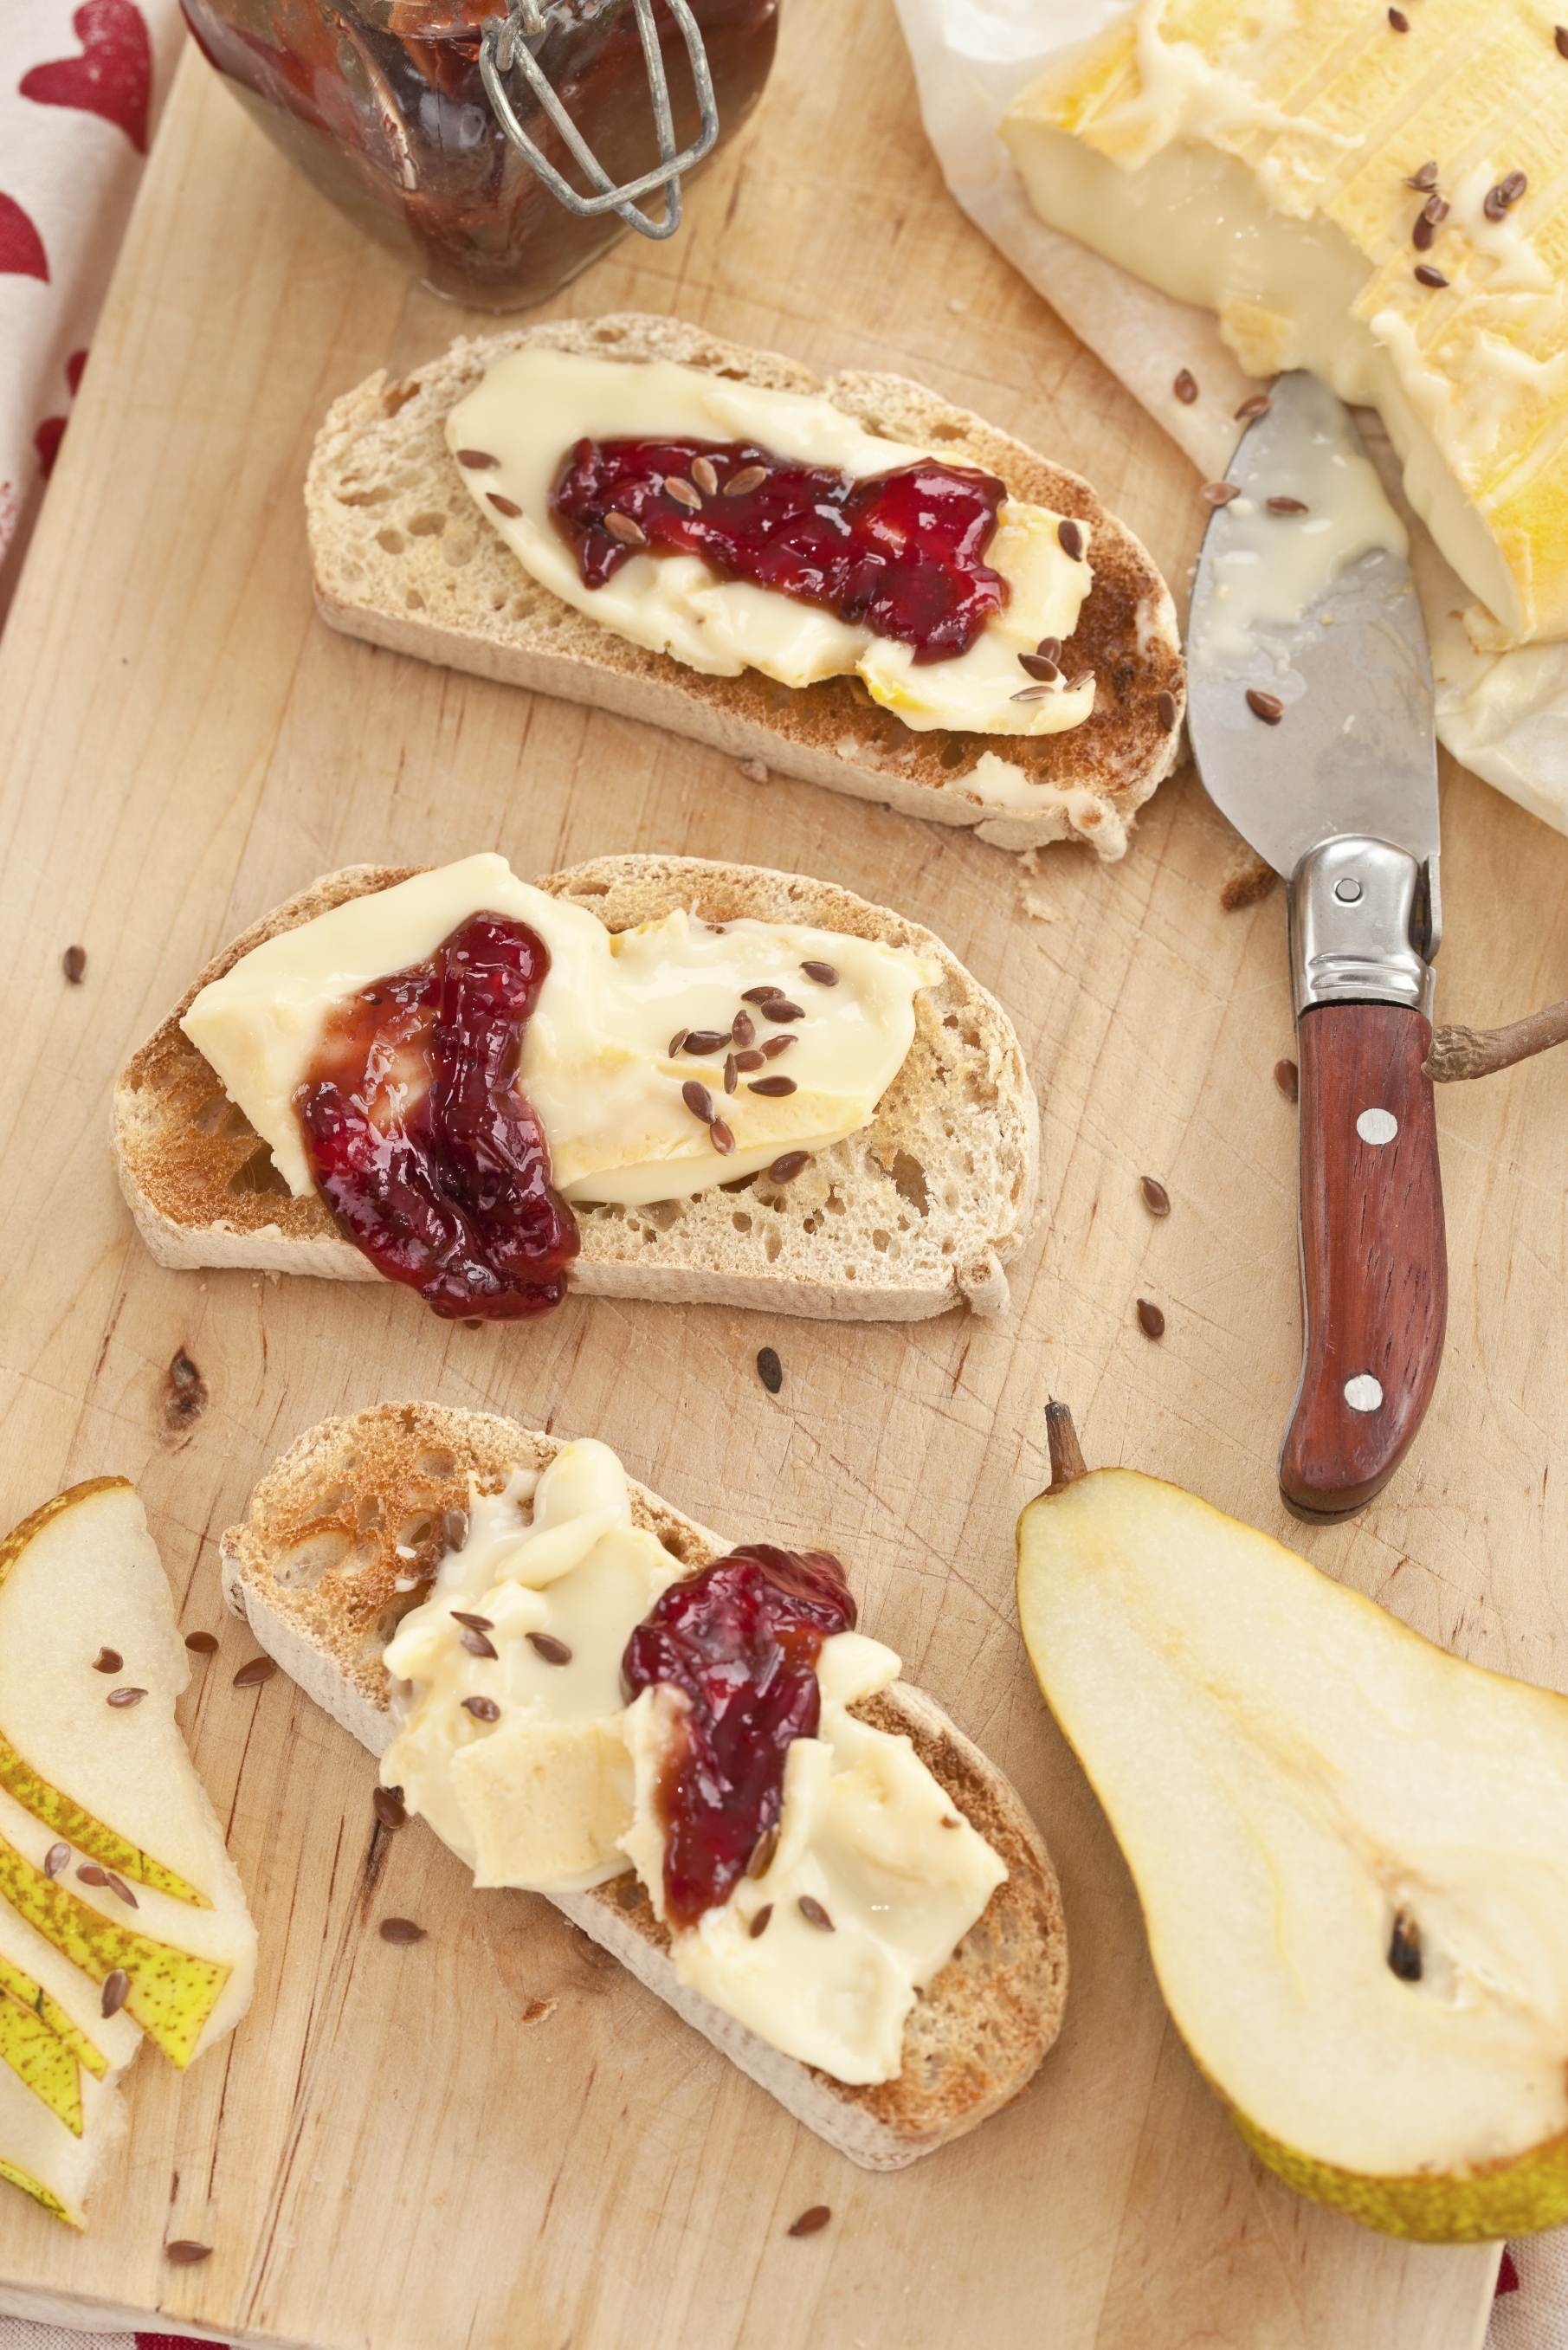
[294,914,578,1320]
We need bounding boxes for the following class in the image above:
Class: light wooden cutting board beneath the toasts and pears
[0,0,1542,2350]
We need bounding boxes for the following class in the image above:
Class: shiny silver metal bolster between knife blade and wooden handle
[1291,832,1441,1020]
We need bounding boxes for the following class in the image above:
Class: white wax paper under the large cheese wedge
[894,0,1568,832]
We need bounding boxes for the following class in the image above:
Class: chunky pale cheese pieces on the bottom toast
[381,1438,1006,2082]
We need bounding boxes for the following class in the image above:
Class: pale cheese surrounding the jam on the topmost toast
[447,350,1094,735]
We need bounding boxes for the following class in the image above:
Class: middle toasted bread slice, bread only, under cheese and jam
[113,855,1039,1320]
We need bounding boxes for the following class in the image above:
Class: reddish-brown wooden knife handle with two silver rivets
[1279,1004,1449,1518]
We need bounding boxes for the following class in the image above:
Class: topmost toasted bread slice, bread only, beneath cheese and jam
[306,313,1184,858]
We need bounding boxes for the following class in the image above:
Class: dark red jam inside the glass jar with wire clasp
[181,0,778,310]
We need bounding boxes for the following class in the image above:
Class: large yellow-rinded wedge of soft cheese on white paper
[1002,0,1568,651]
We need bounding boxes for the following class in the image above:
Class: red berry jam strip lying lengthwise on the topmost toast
[550,440,1006,662]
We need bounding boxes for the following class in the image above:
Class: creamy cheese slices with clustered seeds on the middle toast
[181,853,940,1205]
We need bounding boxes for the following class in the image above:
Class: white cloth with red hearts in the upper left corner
[0,0,184,562]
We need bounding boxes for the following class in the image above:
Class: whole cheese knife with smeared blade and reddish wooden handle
[1187,374,1449,1518]
